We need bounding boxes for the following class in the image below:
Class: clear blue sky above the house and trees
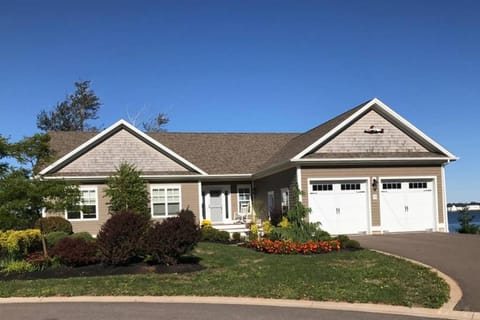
[0,0,480,201]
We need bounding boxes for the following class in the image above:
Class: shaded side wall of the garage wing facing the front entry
[254,168,297,220]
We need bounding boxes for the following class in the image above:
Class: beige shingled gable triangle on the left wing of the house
[58,130,188,175]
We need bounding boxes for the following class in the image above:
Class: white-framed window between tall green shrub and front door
[151,186,180,217]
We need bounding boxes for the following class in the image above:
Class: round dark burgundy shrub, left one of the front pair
[97,211,150,265]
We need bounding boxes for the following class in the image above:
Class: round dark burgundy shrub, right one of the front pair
[145,211,200,265]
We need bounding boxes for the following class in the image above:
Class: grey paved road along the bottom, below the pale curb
[0,302,442,320]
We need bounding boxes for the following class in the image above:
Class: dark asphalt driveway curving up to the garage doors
[352,233,480,312]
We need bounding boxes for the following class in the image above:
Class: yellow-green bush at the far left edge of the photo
[0,229,41,258]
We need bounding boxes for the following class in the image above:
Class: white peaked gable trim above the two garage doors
[291,98,459,161]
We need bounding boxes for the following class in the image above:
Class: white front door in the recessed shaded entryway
[203,186,231,223]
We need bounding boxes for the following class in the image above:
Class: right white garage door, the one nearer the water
[380,179,435,232]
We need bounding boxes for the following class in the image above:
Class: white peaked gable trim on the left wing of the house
[39,119,207,175]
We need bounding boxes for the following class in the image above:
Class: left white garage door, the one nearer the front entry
[308,180,369,234]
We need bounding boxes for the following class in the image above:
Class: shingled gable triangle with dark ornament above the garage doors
[316,110,428,153]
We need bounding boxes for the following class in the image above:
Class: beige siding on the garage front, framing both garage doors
[301,166,444,227]
